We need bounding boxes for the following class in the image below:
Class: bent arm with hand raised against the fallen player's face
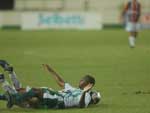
[79,84,93,108]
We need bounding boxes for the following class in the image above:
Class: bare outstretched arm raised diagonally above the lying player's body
[43,64,65,88]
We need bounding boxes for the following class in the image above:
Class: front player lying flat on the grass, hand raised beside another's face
[0,77,100,109]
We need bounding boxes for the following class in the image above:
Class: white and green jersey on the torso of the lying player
[40,83,91,108]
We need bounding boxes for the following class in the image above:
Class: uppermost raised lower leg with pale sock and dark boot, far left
[0,60,21,89]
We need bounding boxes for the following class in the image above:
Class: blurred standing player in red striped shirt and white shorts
[122,0,141,48]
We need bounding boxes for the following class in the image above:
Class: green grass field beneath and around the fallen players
[0,29,150,113]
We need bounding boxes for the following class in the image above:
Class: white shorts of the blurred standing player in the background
[125,22,140,32]
